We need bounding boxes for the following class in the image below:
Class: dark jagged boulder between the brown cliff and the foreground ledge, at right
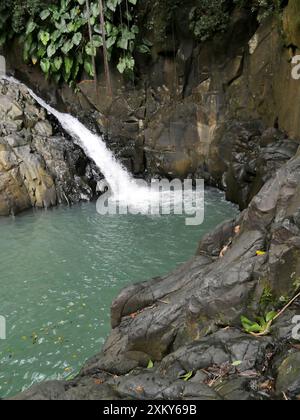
[208,121,299,209]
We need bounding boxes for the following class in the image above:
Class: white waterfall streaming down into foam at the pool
[3,76,204,220]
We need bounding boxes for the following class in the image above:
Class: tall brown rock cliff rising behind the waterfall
[7,0,300,209]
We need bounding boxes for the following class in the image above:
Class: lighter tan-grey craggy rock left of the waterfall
[0,81,101,216]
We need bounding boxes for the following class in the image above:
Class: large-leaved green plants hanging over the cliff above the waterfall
[0,0,149,85]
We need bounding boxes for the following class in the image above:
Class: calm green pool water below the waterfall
[0,190,237,397]
